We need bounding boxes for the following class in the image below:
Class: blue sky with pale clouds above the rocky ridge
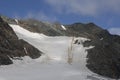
[0,0,120,35]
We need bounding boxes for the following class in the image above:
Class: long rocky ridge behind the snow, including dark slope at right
[2,17,120,78]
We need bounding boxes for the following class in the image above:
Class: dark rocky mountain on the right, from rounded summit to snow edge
[69,23,120,79]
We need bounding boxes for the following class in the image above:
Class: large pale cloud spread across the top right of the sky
[45,0,120,16]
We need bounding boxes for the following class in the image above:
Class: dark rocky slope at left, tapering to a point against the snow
[0,18,42,65]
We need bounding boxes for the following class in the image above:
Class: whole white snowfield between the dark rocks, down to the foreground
[0,25,111,80]
